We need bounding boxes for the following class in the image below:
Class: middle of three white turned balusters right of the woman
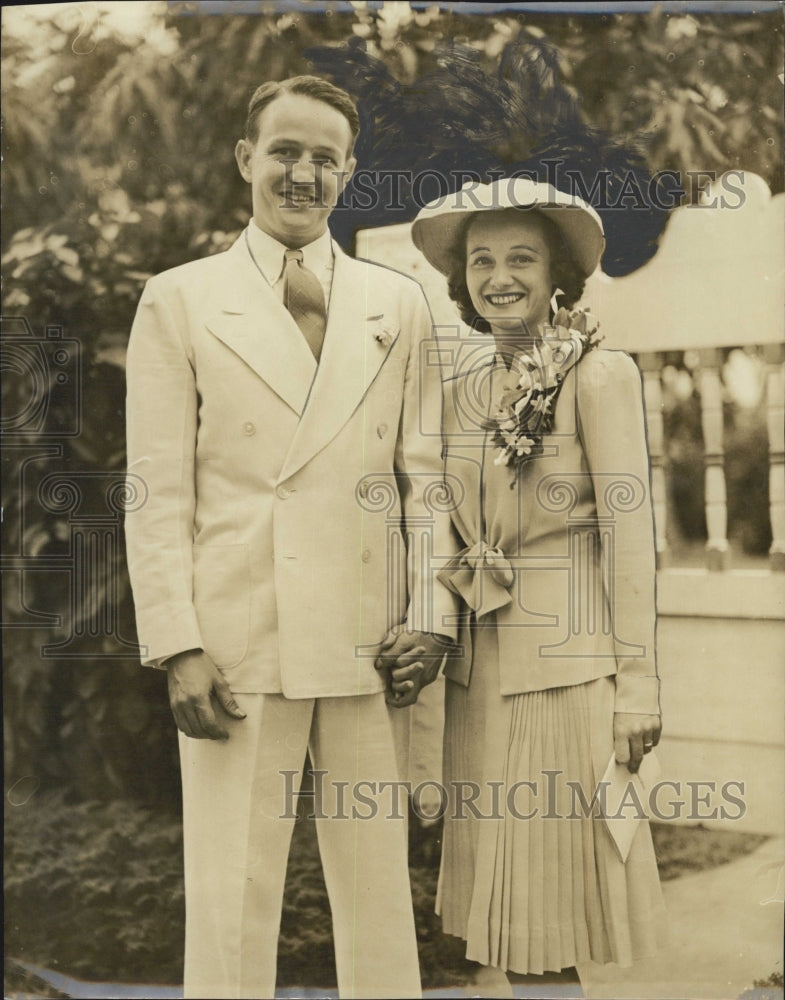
[699,348,728,570]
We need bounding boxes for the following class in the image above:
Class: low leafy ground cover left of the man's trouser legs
[5,795,184,982]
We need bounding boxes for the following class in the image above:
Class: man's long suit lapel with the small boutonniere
[281,244,400,479]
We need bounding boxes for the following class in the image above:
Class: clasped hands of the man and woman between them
[374,625,453,708]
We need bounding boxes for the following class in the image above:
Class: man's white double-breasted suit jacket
[126,229,455,698]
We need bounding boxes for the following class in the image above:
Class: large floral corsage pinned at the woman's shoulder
[490,308,602,486]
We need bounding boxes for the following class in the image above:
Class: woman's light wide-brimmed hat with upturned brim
[412,177,605,278]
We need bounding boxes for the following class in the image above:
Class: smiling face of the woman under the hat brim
[466,209,553,336]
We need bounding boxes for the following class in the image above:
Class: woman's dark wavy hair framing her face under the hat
[447,209,586,333]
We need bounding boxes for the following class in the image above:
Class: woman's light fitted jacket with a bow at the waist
[442,350,659,713]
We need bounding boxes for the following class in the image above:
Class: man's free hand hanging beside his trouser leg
[166,649,245,740]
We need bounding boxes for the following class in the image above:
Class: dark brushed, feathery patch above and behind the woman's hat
[306,37,678,277]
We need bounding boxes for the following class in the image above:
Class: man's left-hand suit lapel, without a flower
[206,235,316,415]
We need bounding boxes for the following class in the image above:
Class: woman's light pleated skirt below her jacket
[436,619,665,974]
